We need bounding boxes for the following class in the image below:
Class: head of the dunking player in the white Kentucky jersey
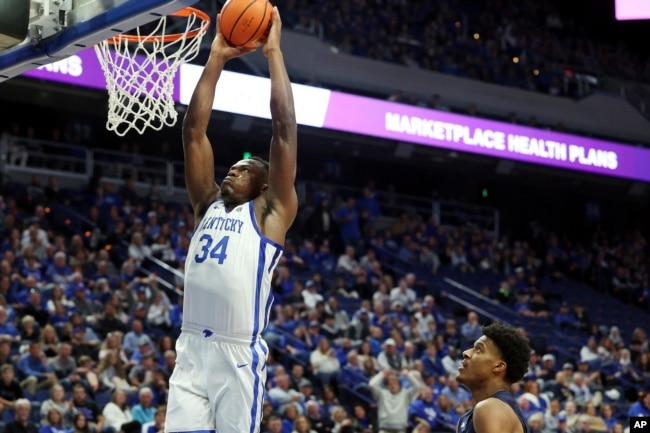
[221,159,266,203]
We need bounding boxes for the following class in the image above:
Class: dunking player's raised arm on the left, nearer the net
[183,17,254,217]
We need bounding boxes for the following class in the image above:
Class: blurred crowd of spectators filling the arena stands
[0,0,650,433]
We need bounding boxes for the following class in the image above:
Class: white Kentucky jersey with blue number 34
[183,199,283,342]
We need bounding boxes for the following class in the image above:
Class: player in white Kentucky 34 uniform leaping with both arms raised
[165,8,298,433]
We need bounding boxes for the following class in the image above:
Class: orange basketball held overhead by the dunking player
[220,0,273,48]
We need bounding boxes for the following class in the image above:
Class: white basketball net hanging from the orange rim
[95,13,208,137]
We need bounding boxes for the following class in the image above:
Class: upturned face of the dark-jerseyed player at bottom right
[457,335,504,388]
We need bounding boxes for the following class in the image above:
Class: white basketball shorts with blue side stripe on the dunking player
[165,326,268,433]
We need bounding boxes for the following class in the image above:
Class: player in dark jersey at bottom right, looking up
[457,324,530,433]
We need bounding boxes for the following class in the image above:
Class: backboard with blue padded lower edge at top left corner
[0,0,198,82]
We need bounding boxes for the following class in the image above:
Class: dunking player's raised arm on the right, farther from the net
[264,7,298,230]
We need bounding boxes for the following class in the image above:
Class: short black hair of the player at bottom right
[483,323,530,383]
